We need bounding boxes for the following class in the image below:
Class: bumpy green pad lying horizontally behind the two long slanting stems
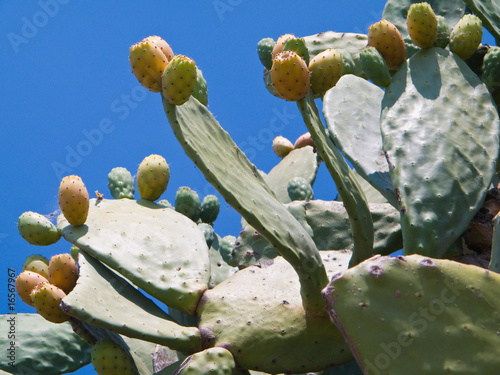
[233,199,403,268]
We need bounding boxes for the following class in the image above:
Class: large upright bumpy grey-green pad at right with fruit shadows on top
[381,48,500,258]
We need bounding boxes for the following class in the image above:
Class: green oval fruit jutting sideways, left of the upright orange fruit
[17,211,61,246]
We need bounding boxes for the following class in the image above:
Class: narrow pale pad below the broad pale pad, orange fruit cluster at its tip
[62,251,200,352]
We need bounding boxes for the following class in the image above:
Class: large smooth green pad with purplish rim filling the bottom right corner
[324,255,500,375]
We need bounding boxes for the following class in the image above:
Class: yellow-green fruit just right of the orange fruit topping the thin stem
[309,48,344,96]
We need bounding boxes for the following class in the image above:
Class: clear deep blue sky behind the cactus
[0,0,492,374]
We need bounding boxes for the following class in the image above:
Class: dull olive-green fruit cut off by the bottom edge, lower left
[90,340,136,375]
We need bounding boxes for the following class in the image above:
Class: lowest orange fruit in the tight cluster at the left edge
[31,282,69,323]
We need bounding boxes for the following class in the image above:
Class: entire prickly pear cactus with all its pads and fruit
[4,0,500,375]
